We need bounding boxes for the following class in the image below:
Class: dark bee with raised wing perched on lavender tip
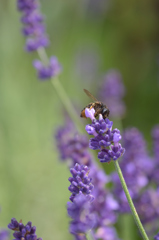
[80,89,110,119]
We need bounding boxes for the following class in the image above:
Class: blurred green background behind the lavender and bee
[0,0,159,240]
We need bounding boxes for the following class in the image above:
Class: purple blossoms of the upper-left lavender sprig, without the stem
[17,0,61,80]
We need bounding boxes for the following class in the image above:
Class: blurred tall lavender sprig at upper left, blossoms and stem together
[17,0,81,129]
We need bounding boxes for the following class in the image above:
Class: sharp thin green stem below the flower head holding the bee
[114,161,149,240]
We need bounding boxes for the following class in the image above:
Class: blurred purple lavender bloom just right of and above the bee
[99,70,125,118]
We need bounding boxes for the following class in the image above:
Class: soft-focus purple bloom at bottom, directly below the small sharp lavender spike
[67,192,95,239]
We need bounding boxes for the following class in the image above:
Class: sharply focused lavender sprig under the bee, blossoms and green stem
[85,108,148,240]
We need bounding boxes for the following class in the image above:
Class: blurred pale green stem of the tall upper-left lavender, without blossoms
[37,48,83,132]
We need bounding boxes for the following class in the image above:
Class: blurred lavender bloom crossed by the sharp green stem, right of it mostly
[112,128,153,212]
